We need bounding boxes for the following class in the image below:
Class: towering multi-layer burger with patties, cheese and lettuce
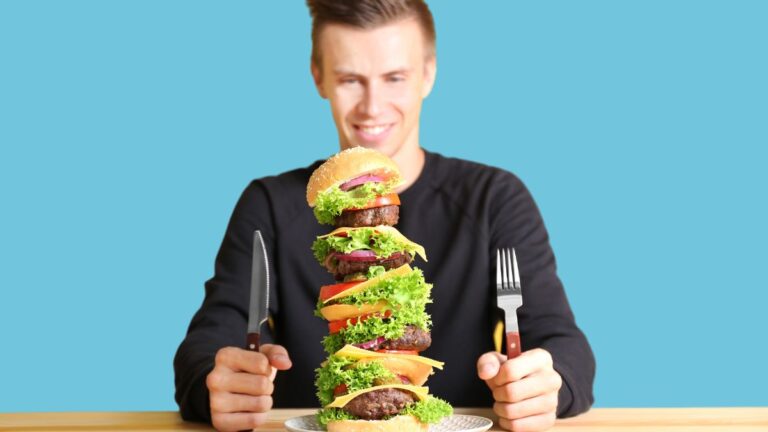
[307,147,453,432]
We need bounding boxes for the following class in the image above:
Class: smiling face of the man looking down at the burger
[312,19,436,157]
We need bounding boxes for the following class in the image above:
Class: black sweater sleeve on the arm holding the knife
[173,181,278,422]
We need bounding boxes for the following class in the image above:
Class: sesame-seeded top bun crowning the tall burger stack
[307,147,402,207]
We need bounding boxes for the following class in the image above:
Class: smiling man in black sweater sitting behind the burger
[175,0,594,431]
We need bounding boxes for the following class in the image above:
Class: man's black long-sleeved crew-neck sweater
[174,152,595,421]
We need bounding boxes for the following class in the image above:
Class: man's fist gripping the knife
[205,344,291,432]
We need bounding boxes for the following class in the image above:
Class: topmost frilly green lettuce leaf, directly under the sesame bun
[313,182,393,225]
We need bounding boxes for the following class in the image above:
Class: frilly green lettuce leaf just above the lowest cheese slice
[315,355,396,406]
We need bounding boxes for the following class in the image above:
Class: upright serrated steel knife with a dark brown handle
[247,230,269,351]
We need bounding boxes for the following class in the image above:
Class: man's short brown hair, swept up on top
[307,0,436,67]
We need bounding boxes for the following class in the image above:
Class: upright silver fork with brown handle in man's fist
[496,248,523,358]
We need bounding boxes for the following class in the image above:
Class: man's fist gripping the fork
[477,348,563,432]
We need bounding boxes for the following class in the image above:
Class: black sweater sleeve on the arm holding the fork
[489,173,595,418]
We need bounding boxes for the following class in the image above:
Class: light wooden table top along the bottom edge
[0,408,768,432]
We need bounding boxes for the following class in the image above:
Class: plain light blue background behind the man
[0,0,768,412]
